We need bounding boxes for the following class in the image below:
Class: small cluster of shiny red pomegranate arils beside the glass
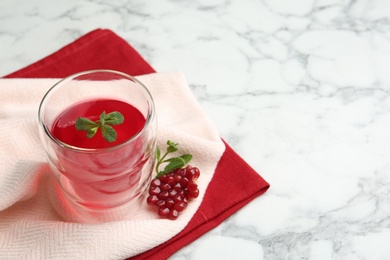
[147,165,200,220]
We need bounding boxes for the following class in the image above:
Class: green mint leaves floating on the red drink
[76,111,125,143]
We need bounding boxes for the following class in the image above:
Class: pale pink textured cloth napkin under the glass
[0,73,225,259]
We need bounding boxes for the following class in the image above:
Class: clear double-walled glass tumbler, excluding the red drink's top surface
[38,70,157,222]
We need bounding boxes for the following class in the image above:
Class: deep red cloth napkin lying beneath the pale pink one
[5,29,269,259]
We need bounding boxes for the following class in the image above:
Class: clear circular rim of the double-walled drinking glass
[38,69,156,153]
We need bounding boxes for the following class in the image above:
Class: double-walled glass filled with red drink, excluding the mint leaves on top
[39,70,157,222]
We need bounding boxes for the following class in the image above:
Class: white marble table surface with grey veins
[0,0,390,260]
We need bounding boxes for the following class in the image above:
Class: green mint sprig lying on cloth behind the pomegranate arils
[156,140,192,178]
